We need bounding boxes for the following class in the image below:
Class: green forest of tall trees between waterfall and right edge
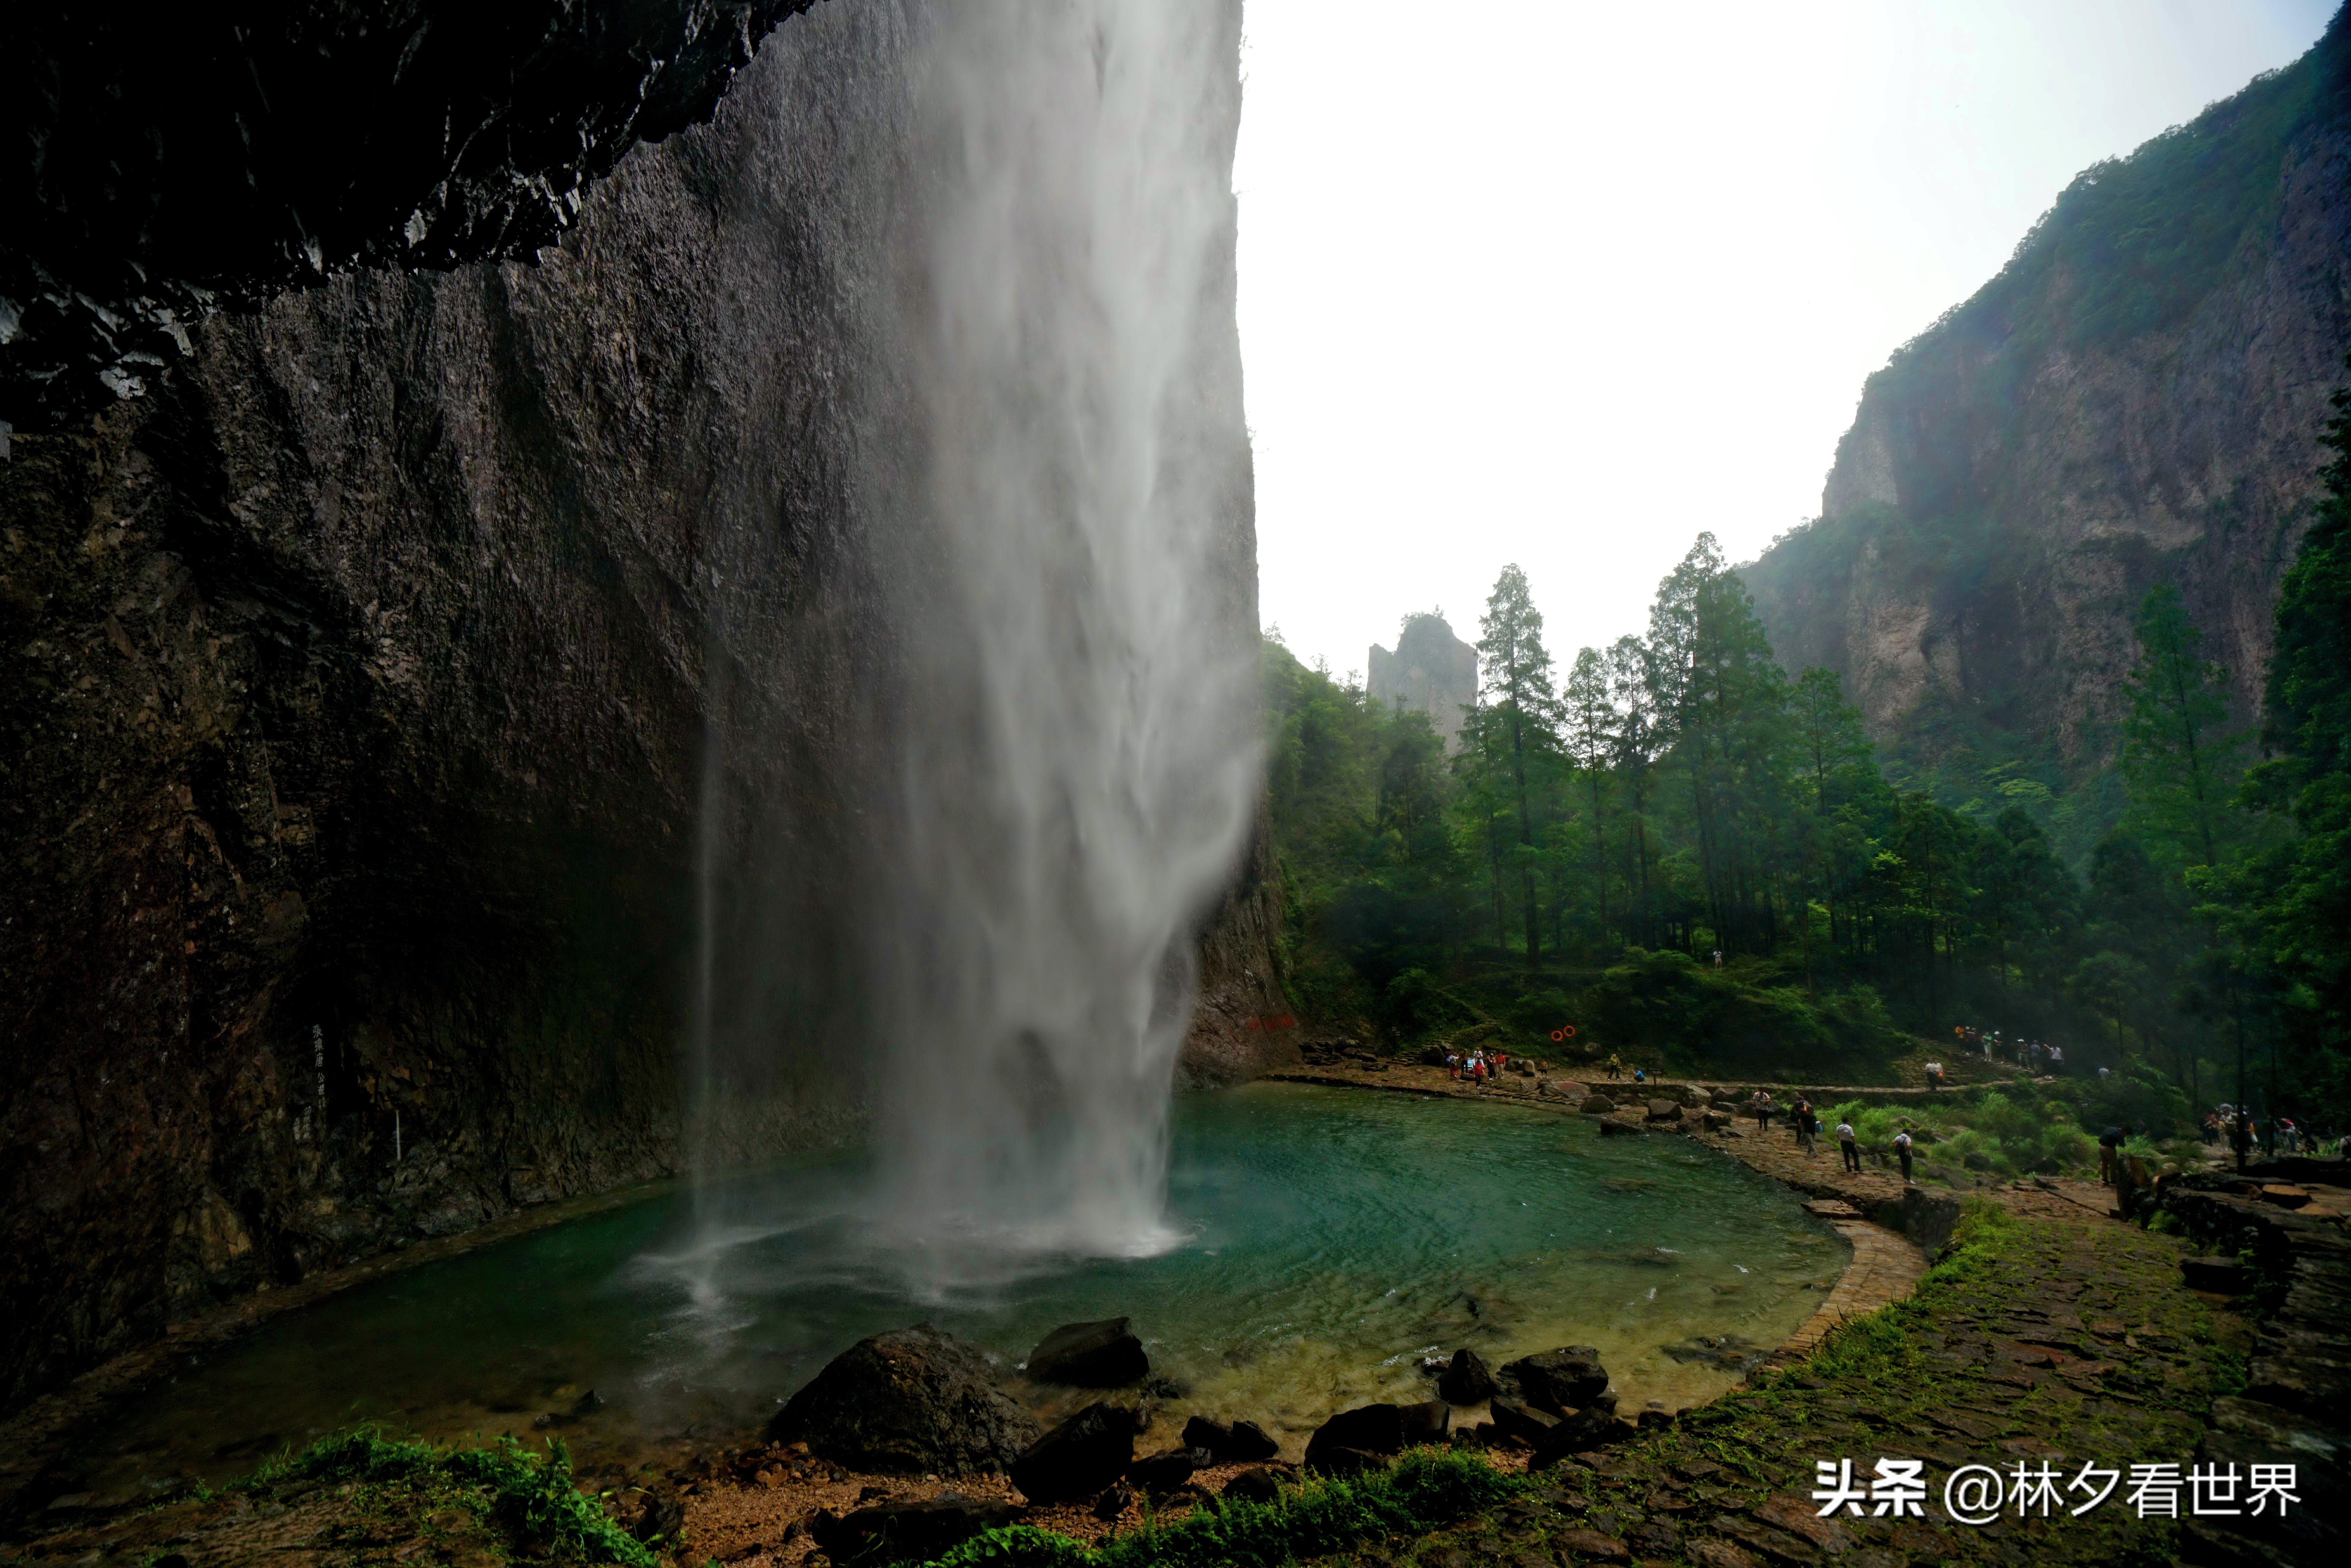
[1265,374,2351,1114]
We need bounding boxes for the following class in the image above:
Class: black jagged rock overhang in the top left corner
[0,0,813,432]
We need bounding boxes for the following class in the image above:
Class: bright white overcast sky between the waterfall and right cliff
[1234,0,2335,672]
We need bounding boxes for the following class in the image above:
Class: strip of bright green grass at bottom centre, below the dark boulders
[917,1448,1524,1568]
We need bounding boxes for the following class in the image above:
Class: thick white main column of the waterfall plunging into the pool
[874,0,1258,1274]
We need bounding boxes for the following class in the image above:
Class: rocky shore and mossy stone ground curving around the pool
[9,1067,2351,1568]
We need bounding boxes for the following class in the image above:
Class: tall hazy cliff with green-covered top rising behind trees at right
[1747,19,2351,849]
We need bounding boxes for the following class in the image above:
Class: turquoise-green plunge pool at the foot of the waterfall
[85,1084,1848,1488]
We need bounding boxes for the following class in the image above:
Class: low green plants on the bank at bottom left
[228,1427,656,1568]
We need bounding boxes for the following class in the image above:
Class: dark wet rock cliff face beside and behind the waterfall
[0,2,1281,1399]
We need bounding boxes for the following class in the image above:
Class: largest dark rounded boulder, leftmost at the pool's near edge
[766,1323,1037,1476]
